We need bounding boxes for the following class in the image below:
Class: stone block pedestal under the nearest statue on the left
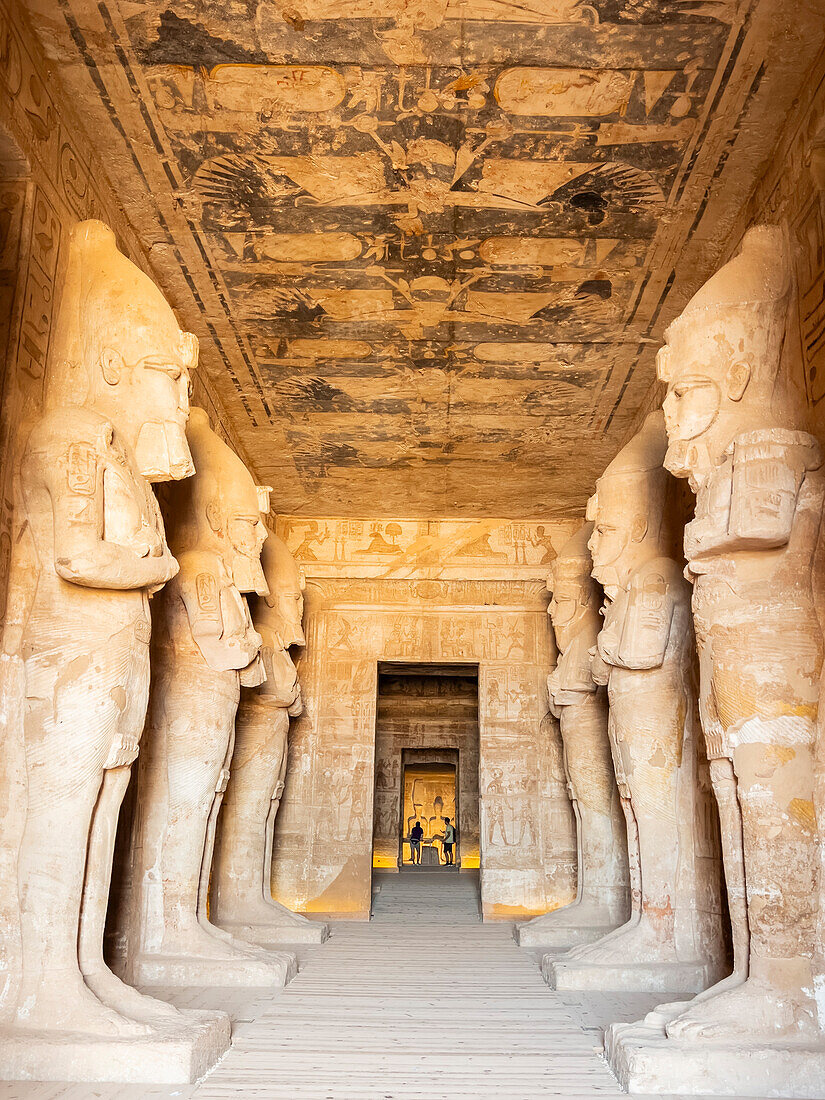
[0,1010,230,1085]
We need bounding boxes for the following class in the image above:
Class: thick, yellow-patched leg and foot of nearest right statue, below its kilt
[668,730,821,1042]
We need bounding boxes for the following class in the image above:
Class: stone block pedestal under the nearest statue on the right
[605,1021,825,1100]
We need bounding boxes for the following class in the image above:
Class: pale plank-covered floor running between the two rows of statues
[0,872,774,1100]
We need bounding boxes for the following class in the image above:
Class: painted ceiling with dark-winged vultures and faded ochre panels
[29,0,822,518]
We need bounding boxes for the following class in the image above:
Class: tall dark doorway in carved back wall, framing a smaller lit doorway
[373,662,480,873]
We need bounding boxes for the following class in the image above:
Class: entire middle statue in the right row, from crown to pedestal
[546,411,724,992]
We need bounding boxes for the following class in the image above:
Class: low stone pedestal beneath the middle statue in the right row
[541,955,717,993]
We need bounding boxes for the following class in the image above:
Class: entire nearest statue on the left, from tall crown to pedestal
[0,221,229,1080]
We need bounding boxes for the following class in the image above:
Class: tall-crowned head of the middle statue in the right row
[587,409,670,600]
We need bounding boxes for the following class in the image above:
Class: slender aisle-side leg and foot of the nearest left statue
[78,766,184,1024]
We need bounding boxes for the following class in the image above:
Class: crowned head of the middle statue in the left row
[169,408,268,596]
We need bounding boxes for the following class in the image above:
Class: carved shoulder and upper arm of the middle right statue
[616,558,690,669]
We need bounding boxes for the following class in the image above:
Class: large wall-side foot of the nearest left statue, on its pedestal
[15,970,154,1038]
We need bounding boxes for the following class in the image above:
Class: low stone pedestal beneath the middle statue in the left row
[131,952,298,989]
